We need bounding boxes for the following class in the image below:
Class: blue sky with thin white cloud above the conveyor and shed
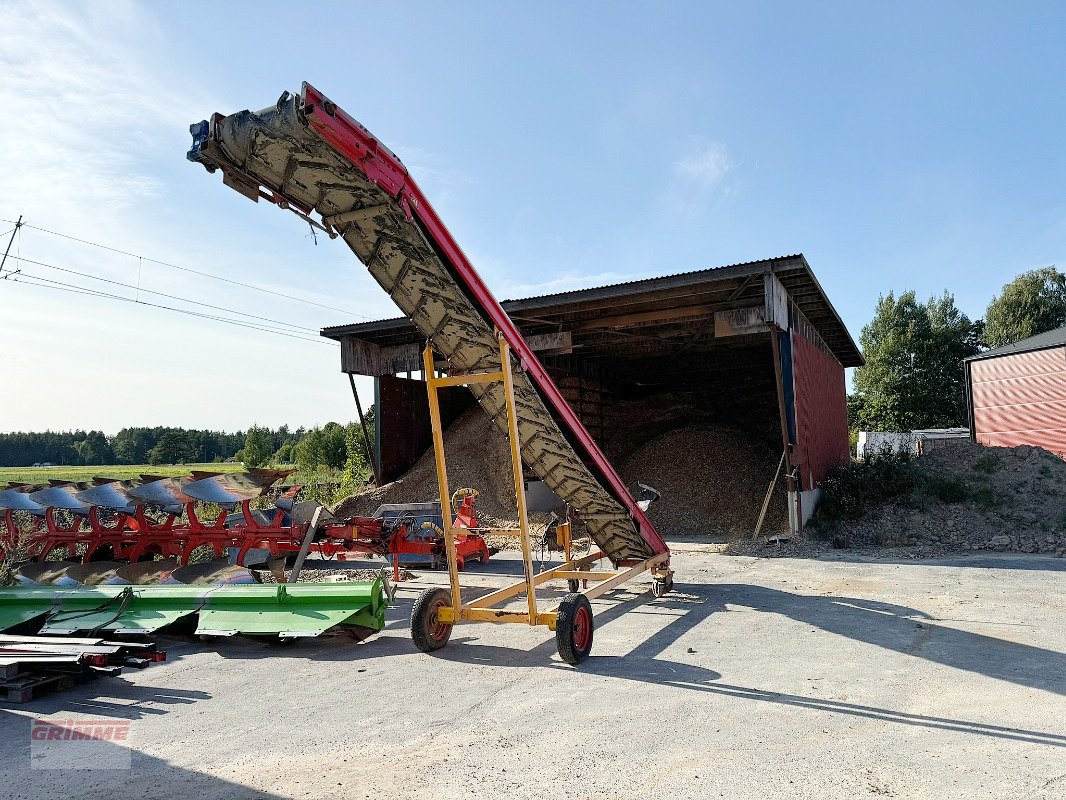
[0,0,1066,433]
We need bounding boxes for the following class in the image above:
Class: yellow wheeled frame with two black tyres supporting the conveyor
[411,334,673,665]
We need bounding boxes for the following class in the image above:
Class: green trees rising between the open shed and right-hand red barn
[847,267,1066,431]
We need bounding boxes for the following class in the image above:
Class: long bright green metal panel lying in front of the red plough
[0,579,386,637]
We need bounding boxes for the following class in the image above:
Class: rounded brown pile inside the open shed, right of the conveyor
[620,425,788,539]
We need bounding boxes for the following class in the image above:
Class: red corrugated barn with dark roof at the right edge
[966,327,1066,459]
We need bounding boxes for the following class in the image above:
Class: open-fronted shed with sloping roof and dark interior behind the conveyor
[322,254,862,530]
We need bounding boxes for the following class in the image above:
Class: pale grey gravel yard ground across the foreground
[0,541,1066,800]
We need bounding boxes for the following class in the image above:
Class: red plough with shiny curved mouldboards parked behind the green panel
[0,469,490,579]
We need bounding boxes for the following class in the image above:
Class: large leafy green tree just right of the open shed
[847,291,982,431]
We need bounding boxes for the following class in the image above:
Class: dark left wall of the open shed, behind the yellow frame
[375,375,474,483]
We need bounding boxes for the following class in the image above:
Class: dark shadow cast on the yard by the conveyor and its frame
[424,585,1066,747]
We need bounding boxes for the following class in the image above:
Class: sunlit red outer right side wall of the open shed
[792,331,850,491]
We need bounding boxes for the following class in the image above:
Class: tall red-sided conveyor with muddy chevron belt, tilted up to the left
[189,83,667,563]
